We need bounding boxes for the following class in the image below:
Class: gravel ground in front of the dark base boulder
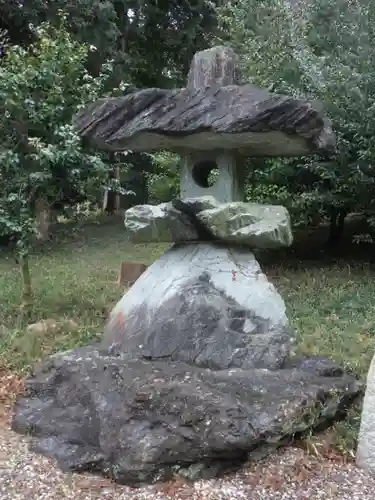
[0,419,375,500]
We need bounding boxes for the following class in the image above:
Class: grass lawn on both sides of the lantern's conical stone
[0,220,375,452]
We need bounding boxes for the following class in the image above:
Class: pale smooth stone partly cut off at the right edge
[357,356,375,475]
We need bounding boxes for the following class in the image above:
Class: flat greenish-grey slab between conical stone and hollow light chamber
[125,196,293,249]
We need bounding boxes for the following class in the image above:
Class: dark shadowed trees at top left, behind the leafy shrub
[0,0,216,87]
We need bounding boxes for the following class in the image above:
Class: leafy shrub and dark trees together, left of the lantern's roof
[0,0,216,300]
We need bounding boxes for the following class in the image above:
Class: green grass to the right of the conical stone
[263,262,375,458]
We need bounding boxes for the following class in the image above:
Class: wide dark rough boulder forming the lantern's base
[12,347,362,485]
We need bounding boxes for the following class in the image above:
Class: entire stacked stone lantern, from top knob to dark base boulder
[12,47,363,484]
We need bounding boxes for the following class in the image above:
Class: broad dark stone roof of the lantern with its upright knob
[75,47,335,156]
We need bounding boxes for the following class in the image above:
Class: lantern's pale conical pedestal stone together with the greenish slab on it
[108,189,293,369]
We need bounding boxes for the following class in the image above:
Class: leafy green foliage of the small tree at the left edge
[0,15,128,252]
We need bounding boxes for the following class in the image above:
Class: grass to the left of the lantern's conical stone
[0,220,166,371]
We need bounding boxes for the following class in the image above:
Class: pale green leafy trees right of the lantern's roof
[219,0,375,227]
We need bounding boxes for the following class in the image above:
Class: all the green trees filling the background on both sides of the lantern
[0,0,375,302]
